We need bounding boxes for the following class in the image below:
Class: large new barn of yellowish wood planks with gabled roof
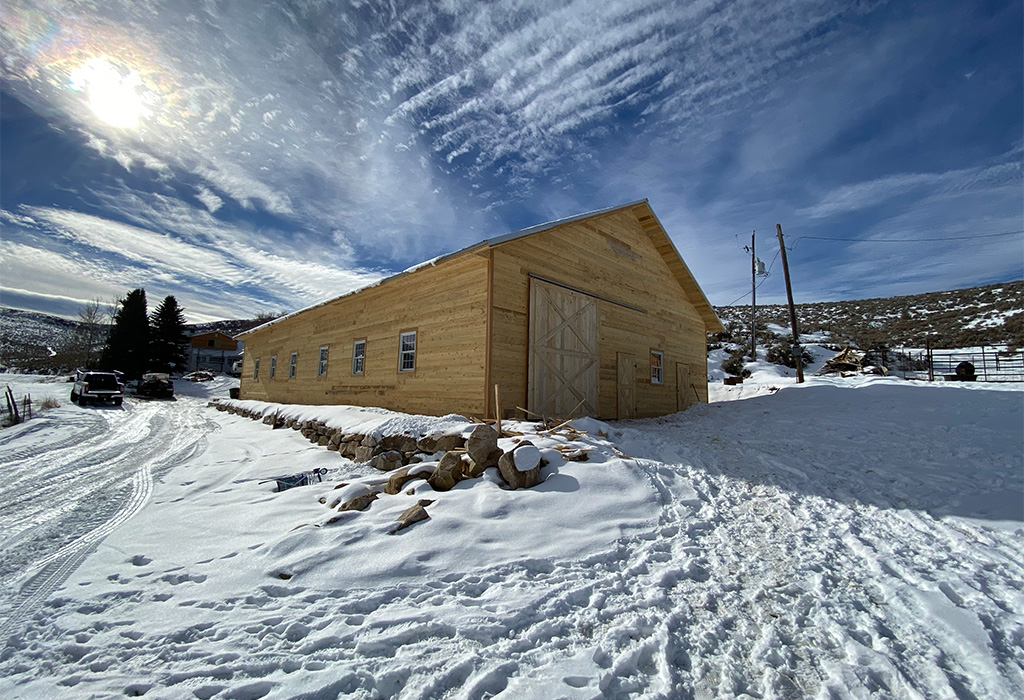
[239,200,722,419]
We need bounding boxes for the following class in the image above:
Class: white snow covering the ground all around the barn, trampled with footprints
[0,368,1024,700]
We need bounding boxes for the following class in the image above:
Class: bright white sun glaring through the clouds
[71,57,148,129]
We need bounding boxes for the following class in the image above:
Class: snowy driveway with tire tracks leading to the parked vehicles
[0,390,210,639]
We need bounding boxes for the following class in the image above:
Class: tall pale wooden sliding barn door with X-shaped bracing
[527,279,598,418]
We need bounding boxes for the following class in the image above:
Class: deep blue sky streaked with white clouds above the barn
[0,0,1024,321]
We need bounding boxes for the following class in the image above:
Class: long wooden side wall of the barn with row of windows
[242,254,488,415]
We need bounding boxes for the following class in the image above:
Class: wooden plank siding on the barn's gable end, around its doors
[488,204,708,419]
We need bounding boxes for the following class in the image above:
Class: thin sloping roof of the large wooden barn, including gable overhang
[236,199,724,338]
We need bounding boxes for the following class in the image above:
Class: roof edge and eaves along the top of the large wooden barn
[234,198,722,338]
